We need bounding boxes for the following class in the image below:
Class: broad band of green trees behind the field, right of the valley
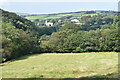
[41,29,120,52]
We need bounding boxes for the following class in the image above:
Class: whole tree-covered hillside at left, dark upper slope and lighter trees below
[0,11,40,61]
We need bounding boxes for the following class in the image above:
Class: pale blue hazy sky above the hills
[0,0,118,14]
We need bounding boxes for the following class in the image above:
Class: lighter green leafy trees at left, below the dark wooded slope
[2,23,40,60]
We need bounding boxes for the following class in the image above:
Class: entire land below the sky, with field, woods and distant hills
[0,9,120,80]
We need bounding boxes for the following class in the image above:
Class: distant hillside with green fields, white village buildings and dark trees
[21,10,117,34]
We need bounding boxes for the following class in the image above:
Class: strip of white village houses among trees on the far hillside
[34,16,113,27]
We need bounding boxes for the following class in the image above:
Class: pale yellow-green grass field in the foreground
[1,52,118,78]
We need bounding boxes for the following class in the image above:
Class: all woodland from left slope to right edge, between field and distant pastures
[0,10,120,62]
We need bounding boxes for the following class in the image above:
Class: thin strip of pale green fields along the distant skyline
[25,10,117,21]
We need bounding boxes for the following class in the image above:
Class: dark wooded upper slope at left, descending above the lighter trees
[0,9,35,31]
